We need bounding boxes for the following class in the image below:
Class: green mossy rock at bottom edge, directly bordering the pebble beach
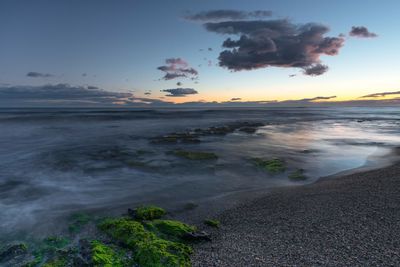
[134,238,193,267]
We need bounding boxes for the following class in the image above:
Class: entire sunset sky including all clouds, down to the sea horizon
[0,0,400,107]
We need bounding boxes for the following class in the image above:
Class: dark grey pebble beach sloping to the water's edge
[193,148,400,266]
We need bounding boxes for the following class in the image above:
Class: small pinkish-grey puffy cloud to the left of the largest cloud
[157,58,199,80]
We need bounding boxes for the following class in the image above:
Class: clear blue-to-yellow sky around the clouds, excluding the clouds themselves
[0,0,400,107]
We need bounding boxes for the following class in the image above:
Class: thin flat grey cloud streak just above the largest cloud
[184,9,272,21]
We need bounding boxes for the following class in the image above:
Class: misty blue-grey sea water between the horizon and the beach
[0,108,400,242]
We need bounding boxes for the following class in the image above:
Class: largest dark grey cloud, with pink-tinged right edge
[204,19,345,75]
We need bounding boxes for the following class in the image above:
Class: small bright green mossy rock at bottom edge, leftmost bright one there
[91,240,124,267]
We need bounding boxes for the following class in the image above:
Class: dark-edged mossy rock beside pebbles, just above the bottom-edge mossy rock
[146,220,197,240]
